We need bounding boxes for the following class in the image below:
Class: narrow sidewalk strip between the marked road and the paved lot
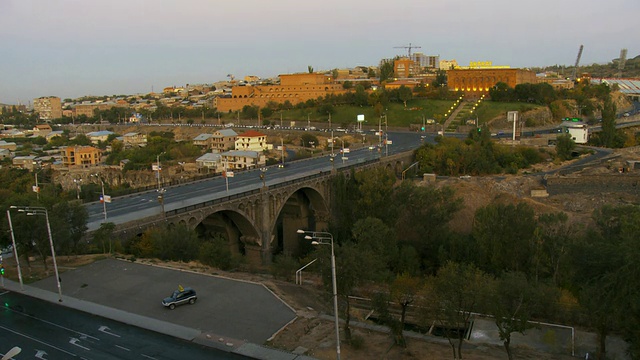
[4,279,316,360]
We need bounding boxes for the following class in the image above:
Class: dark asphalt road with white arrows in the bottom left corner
[0,291,249,360]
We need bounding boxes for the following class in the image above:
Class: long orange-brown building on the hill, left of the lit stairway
[214,73,346,112]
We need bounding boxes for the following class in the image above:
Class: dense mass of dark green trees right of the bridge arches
[312,165,640,359]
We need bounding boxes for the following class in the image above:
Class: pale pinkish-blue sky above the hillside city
[0,0,640,104]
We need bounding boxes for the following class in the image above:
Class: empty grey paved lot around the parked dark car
[31,259,296,344]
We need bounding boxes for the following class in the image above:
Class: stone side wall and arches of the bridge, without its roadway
[116,152,412,265]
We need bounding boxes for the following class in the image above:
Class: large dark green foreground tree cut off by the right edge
[570,205,640,359]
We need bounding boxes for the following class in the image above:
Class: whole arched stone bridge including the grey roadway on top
[86,132,428,264]
